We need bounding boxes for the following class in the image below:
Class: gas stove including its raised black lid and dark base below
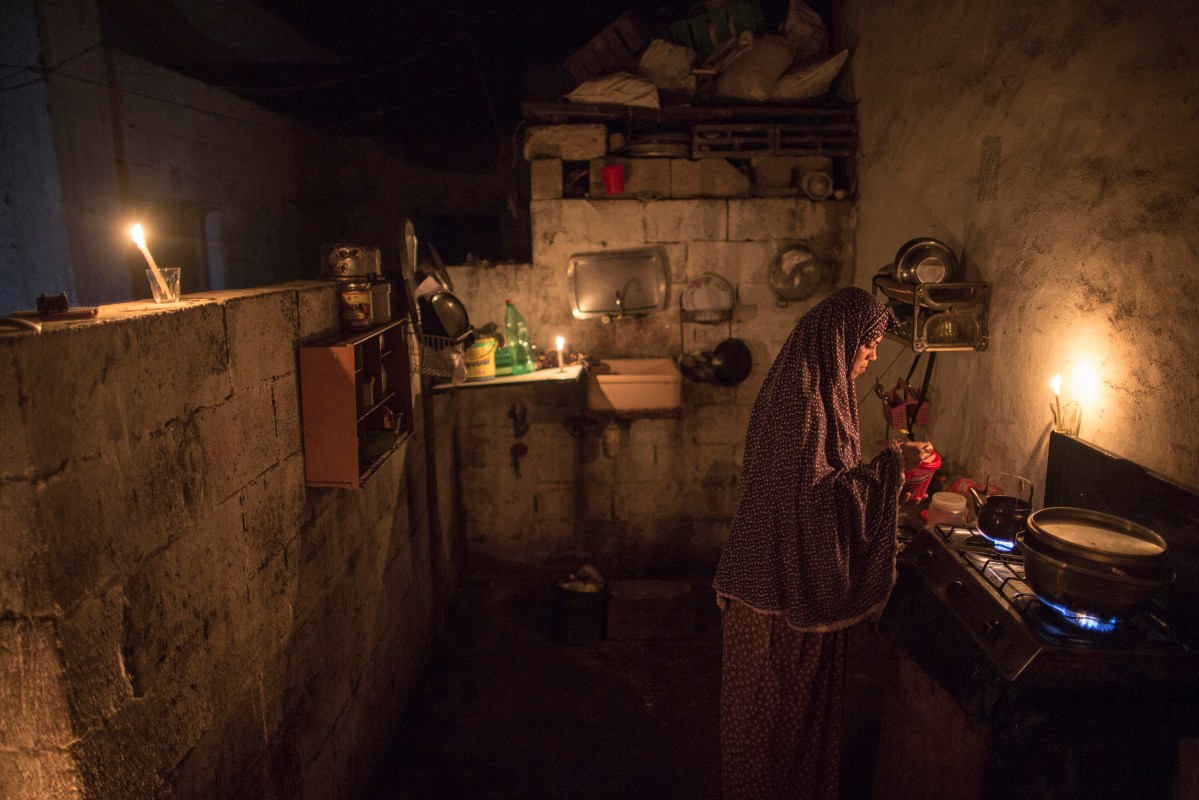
[879,433,1199,800]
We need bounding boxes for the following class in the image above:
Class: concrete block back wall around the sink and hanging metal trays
[448,194,855,576]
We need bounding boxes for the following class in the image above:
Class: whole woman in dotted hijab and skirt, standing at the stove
[713,288,932,800]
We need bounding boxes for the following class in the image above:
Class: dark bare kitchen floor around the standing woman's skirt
[362,566,882,800]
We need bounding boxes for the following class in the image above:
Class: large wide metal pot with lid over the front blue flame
[1016,507,1175,616]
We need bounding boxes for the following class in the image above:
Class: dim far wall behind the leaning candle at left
[0,0,504,313]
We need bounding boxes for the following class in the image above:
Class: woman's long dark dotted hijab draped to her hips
[715,288,903,631]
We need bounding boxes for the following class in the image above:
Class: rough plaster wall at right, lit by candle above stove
[838,0,1199,487]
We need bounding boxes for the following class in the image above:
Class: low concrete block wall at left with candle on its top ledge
[0,282,458,800]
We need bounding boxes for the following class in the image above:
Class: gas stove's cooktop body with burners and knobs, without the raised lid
[882,524,1199,691]
